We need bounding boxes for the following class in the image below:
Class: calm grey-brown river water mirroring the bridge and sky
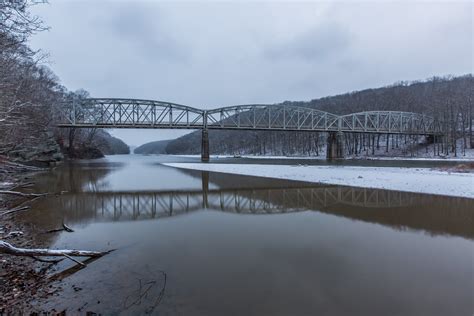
[20,155,474,315]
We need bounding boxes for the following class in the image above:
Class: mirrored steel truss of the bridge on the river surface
[60,187,412,221]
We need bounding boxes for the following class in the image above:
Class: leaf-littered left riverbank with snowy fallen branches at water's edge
[0,158,112,315]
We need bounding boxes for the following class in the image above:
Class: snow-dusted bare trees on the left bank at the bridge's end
[0,0,129,164]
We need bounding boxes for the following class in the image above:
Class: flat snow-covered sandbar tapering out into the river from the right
[164,163,474,199]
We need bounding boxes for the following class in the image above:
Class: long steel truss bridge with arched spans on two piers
[58,98,441,161]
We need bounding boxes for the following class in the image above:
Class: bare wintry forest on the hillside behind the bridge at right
[166,74,474,156]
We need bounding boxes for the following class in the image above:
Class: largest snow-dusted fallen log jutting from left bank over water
[0,240,111,258]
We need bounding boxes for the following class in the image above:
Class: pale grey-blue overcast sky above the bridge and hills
[32,0,474,145]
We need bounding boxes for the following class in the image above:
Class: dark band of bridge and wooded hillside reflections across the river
[25,164,474,239]
